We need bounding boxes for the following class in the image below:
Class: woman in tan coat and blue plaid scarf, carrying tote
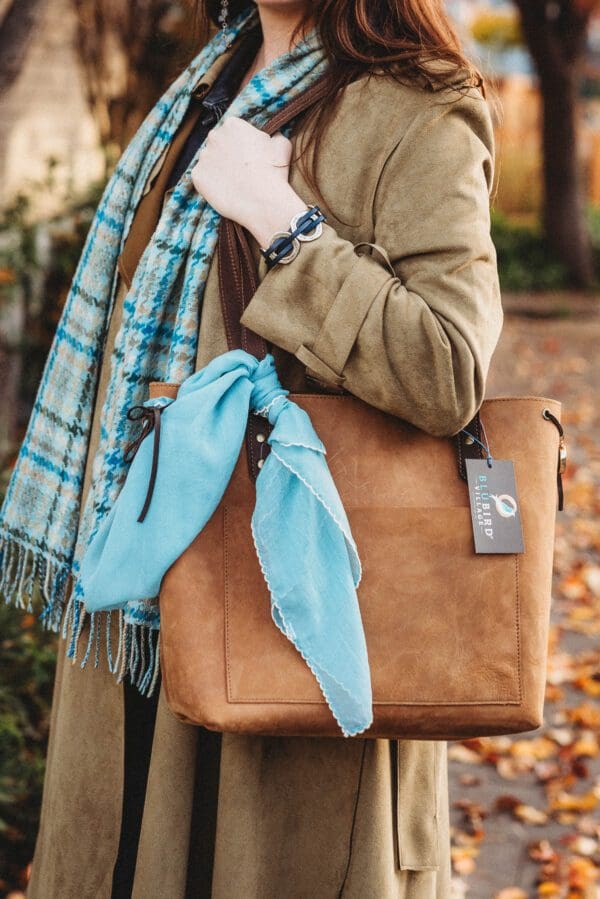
[3,0,502,899]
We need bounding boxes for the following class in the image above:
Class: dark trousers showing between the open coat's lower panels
[111,682,221,899]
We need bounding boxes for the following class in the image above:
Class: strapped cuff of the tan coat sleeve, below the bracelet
[241,224,390,387]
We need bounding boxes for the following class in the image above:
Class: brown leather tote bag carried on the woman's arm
[156,82,564,740]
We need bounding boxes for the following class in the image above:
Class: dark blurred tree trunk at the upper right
[515,0,596,287]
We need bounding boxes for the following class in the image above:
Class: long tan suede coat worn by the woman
[28,47,502,899]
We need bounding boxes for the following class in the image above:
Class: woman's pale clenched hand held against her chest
[192,116,306,247]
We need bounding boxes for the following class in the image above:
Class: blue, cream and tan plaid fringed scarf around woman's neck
[0,10,326,692]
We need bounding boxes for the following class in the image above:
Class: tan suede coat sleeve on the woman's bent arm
[242,87,502,436]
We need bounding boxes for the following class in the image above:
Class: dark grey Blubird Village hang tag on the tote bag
[465,459,525,553]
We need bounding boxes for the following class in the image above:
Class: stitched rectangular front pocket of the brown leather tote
[224,506,521,706]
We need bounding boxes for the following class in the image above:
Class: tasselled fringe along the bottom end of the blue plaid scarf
[0,534,160,697]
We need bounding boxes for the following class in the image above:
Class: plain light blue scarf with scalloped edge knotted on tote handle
[80,350,372,736]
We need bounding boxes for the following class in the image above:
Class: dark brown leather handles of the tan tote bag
[217,76,482,481]
